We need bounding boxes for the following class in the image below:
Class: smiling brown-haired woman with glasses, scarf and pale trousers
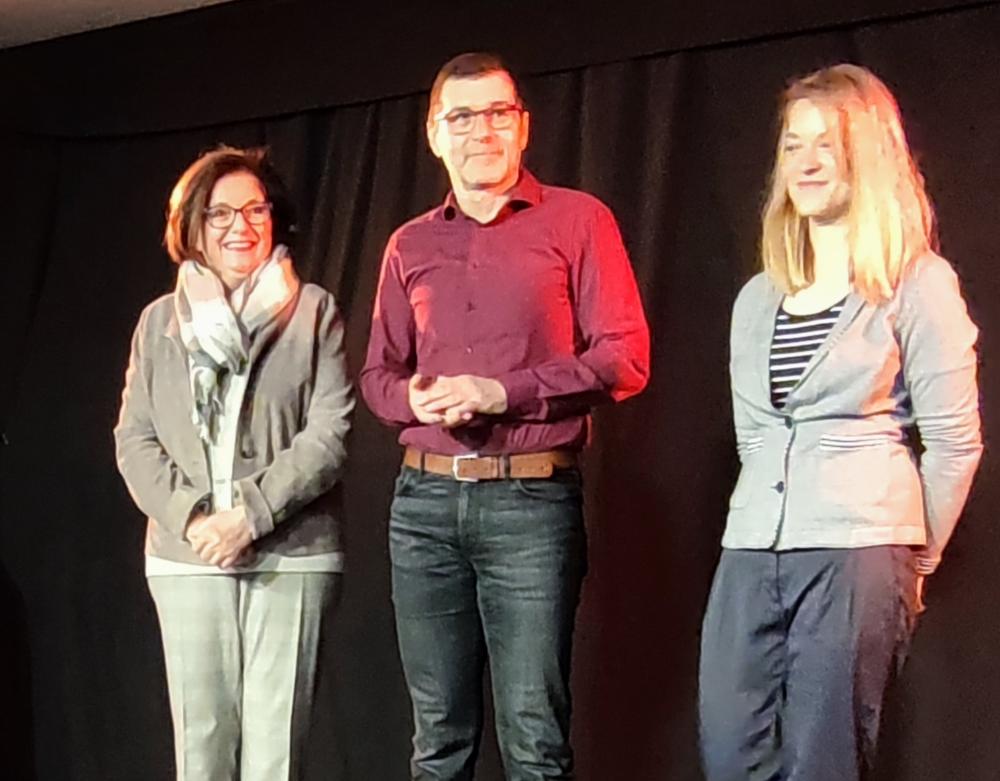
[115,147,353,781]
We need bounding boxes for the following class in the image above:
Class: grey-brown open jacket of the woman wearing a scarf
[114,284,354,564]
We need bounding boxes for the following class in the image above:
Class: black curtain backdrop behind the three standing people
[0,0,1000,781]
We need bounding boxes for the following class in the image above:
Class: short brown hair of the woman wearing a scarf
[163,145,295,263]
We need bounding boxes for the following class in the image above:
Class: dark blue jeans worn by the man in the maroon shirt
[389,467,586,781]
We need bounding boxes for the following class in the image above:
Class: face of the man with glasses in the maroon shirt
[427,71,529,193]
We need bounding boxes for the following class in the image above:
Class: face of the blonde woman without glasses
[780,99,851,222]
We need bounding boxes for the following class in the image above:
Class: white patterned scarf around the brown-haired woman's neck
[174,244,299,443]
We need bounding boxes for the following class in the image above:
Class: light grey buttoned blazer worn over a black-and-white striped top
[722,253,982,563]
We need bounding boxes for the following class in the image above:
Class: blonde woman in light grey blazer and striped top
[700,65,982,781]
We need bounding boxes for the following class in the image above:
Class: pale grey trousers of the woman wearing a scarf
[147,572,340,781]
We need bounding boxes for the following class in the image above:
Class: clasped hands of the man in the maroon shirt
[408,374,507,428]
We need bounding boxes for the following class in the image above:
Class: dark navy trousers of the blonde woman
[699,546,917,781]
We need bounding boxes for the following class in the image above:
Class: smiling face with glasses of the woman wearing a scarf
[198,171,273,289]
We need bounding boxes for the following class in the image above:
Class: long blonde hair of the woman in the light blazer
[760,64,935,302]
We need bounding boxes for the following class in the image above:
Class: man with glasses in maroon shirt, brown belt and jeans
[361,53,649,781]
